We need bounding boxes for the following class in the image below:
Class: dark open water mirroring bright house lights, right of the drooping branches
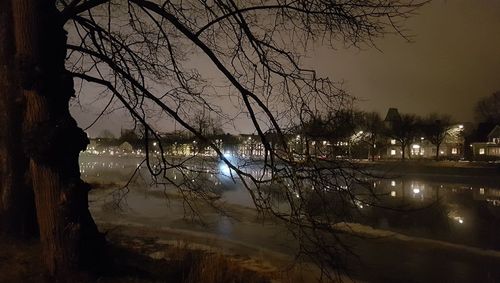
[356,179,500,249]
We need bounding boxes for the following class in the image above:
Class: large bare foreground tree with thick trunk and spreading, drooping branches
[1,0,425,281]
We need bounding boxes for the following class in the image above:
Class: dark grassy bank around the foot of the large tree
[0,233,272,283]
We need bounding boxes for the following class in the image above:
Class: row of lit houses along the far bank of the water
[86,108,500,160]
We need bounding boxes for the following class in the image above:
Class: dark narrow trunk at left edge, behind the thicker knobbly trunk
[0,0,38,237]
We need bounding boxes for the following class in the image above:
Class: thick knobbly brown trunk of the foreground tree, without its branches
[13,0,104,282]
